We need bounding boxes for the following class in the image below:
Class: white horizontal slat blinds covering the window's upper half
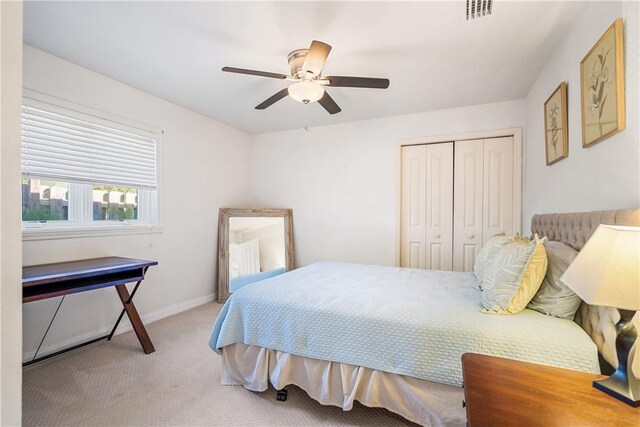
[22,98,157,189]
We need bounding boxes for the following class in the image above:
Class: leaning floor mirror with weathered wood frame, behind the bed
[218,208,294,303]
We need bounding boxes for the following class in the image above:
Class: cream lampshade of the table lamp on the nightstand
[560,225,640,311]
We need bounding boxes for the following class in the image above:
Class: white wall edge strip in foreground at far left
[0,1,22,426]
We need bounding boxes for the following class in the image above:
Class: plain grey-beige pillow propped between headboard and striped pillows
[527,242,582,320]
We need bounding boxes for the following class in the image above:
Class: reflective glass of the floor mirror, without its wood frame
[229,217,286,293]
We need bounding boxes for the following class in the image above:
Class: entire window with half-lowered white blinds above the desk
[22,91,161,237]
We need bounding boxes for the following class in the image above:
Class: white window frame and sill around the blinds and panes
[21,88,164,241]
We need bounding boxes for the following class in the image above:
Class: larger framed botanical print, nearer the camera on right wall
[580,18,625,147]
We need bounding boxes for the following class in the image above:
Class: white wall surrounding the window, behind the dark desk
[23,45,250,362]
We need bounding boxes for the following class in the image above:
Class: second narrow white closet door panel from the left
[425,142,453,270]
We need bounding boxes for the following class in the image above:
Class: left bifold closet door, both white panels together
[400,143,453,270]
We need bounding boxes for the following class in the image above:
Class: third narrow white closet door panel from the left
[453,139,484,271]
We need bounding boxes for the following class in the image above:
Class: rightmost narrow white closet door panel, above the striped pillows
[482,137,514,243]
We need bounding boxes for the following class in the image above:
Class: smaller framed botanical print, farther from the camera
[544,82,569,166]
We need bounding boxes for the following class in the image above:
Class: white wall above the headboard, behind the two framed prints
[523,2,640,227]
